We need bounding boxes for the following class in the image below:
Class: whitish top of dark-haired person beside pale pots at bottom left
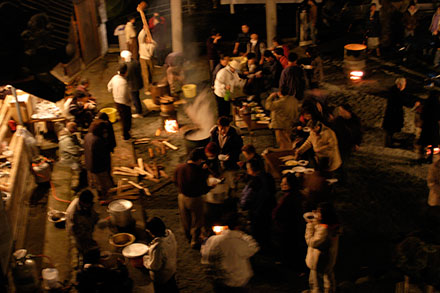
[144,229,177,283]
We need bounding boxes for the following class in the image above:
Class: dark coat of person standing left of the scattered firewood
[84,133,111,173]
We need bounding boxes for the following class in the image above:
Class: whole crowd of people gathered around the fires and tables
[51,4,440,292]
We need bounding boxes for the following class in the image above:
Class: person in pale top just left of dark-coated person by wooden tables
[58,122,87,192]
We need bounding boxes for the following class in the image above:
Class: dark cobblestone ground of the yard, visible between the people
[24,51,438,292]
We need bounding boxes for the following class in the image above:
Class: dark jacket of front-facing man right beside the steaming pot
[211,126,243,170]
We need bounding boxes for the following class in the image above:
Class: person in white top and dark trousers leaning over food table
[214,60,246,117]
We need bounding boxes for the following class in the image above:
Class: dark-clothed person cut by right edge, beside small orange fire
[416,91,440,164]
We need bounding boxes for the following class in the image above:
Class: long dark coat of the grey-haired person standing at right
[382,86,412,133]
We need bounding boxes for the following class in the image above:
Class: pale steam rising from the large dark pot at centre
[185,87,216,135]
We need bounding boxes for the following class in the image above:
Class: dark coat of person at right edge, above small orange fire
[418,95,440,147]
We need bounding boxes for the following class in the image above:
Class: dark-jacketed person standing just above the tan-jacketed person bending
[279,52,305,101]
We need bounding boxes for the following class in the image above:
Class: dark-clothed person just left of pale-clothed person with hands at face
[272,173,306,273]
